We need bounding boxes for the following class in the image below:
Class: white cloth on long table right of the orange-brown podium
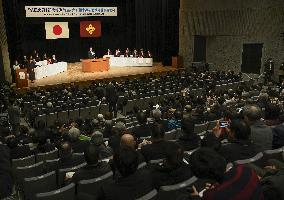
[104,56,153,67]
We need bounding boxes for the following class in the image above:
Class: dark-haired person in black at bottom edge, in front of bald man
[97,147,154,200]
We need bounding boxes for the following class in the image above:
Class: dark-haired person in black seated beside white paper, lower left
[72,144,111,183]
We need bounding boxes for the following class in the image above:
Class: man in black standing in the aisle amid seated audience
[106,81,118,118]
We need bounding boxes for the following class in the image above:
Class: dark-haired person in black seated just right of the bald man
[141,123,174,162]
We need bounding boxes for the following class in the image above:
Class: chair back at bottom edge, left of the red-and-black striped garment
[158,176,197,200]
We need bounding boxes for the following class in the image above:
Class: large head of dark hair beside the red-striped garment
[190,147,226,183]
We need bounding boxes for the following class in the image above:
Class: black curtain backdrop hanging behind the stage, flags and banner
[3,0,179,65]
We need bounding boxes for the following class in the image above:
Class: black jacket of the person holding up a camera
[219,140,259,163]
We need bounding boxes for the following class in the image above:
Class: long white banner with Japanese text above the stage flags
[25,6,117,17]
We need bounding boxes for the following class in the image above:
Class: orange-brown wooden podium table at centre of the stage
[81,58,109,72]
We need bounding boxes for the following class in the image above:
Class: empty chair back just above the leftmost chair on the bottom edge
[24,171,57,200]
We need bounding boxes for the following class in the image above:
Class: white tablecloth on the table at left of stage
[35,61,67,80]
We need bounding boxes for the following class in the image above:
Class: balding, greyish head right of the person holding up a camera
[243,105,262,125]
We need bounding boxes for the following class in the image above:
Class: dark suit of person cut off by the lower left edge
[0,144,13,199]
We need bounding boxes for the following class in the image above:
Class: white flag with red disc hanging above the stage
[45,22,69,39]
